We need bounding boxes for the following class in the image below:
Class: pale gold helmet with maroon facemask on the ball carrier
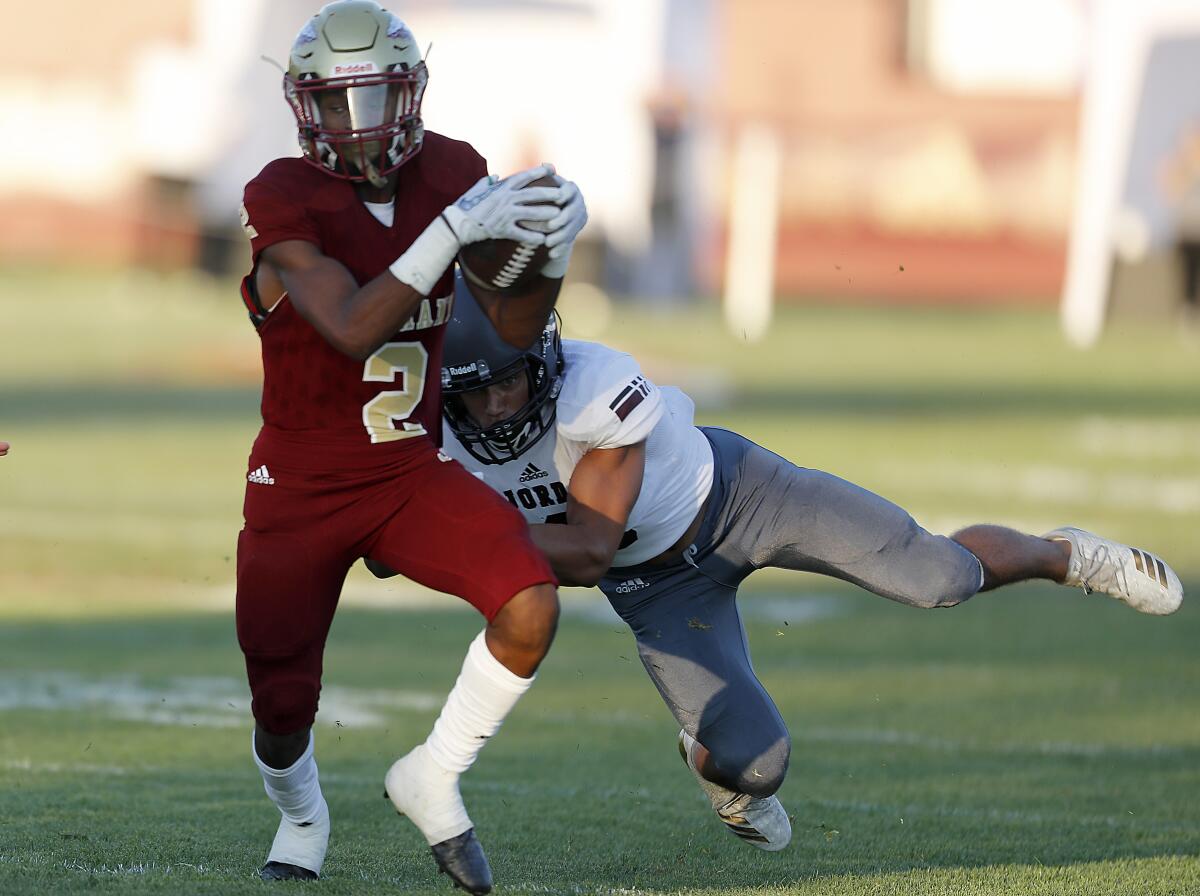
[283,0,428,186]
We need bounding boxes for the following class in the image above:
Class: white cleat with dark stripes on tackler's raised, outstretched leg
[1042,525,1183,617]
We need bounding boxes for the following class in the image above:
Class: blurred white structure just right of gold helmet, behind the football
[410,0,664,251]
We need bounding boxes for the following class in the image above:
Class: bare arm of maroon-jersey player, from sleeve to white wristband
[259,240,425,360]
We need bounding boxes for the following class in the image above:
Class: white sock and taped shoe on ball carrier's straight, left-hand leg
[250,732,329,874]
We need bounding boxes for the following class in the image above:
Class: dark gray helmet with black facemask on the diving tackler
[442,272,563,464]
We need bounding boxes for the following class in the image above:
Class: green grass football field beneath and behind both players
[0,270,1200,896]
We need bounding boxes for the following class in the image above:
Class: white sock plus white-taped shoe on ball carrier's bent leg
[385,632,533,846]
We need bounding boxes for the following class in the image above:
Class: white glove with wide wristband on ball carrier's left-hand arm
[388,164,565,295]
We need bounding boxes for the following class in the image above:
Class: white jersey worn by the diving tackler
[442,339,713,566]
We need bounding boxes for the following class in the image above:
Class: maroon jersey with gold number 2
[242,132,487,463]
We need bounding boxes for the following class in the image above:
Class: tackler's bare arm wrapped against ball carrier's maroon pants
[529,441,646,585]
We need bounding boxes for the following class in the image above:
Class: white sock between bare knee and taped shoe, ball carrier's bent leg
[425,632,533,775]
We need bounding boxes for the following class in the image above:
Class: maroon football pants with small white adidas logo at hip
[236,428,554,734]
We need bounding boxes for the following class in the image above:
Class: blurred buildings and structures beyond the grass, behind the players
[7,0,1200,323]
